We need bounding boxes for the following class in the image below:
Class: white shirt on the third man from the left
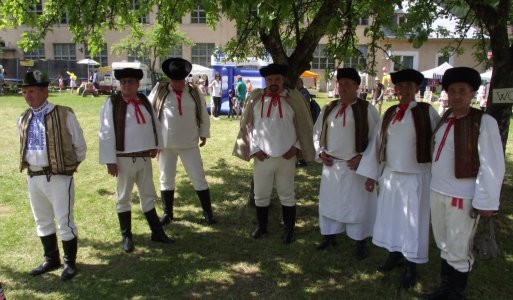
[148,84,210,149]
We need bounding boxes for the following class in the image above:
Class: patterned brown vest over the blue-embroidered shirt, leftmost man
[20,105,80,175]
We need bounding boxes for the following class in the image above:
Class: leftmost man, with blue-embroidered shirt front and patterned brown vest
[18,70,87,281]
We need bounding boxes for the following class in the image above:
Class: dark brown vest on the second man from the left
[110,93,158,151]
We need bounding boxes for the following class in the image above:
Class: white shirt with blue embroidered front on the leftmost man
[18,102,87,170]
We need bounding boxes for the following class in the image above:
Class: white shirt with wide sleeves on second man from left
[98,99,162,164]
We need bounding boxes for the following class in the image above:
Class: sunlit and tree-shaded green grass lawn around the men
[0,94,513,299]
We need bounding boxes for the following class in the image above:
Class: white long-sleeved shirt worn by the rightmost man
[431,114,505,210]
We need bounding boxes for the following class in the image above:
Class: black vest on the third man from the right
[319,98,369,153]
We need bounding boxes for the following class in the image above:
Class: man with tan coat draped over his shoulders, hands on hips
[233,64,315,244]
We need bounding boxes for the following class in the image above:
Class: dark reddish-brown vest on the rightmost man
[432,107,483,178]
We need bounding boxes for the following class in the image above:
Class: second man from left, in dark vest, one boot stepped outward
[99,68,173,252]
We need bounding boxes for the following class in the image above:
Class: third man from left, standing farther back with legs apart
[149,58,216,225]
